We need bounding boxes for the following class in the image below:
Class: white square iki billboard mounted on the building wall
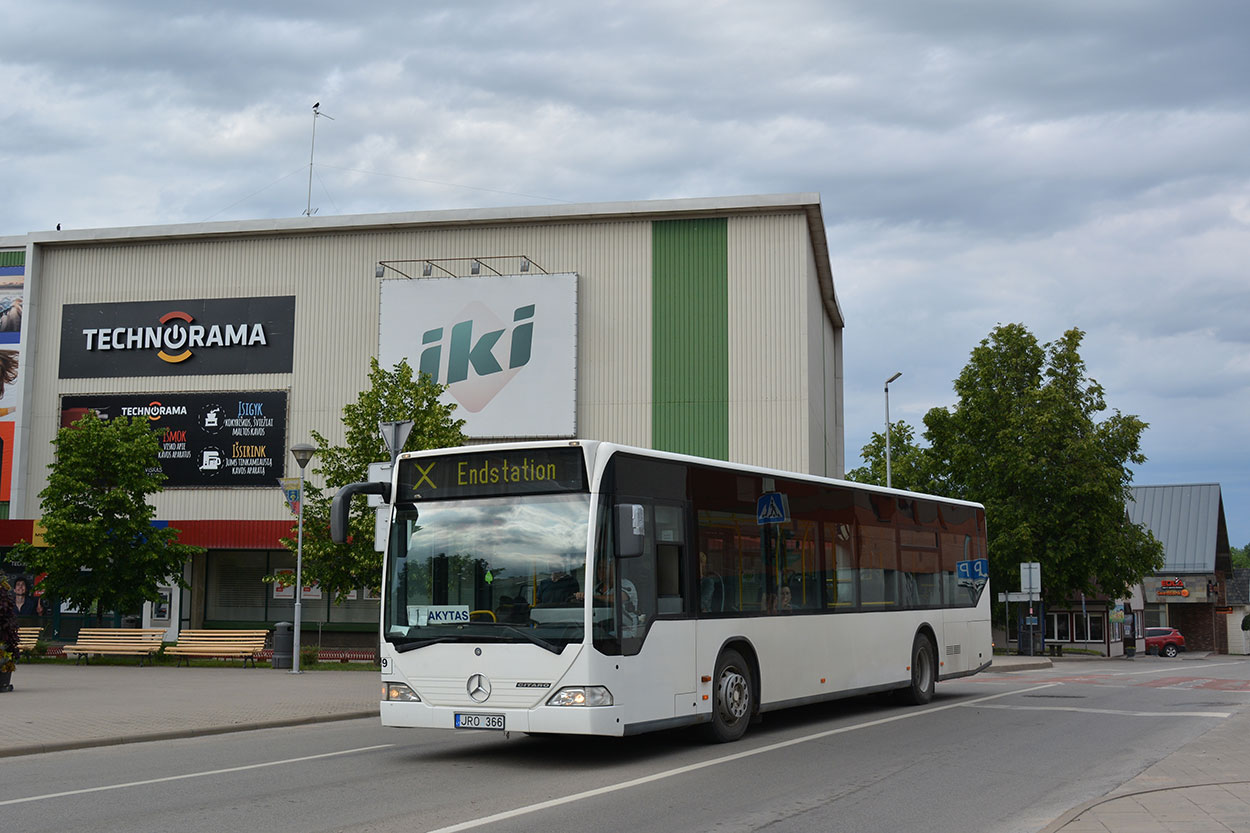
[378,273,578,438]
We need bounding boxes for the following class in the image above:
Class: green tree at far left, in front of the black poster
[13,411,201,622]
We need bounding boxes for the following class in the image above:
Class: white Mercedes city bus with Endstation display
[333,440,991,740]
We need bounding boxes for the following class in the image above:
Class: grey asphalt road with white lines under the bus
[0,658,1250,833]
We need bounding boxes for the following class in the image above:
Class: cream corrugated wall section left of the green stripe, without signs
[24,221,651,520]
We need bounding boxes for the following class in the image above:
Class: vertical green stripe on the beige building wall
[651,218,729,459]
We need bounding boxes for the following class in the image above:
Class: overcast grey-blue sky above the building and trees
[0,0,1250,545]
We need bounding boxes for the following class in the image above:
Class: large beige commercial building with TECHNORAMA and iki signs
[0,194,845,638]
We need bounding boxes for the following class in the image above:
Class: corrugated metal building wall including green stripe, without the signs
[14,211,841,520]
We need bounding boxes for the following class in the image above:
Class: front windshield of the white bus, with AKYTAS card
[383,493,590,653]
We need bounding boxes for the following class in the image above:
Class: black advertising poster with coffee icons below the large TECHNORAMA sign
[61,390,286,489]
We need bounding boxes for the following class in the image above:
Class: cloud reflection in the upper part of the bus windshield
[409,495,590,573]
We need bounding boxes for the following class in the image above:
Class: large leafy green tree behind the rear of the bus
[925,324,1164,604]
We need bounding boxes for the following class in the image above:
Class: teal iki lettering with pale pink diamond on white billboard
[419,301,535,414]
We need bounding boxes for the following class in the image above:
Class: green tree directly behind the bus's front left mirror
[283,359,465,599]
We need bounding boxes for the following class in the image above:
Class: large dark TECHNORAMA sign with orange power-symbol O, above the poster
[60,295,295,379]
